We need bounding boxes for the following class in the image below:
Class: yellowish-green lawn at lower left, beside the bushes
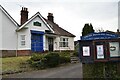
[2,56,30,74]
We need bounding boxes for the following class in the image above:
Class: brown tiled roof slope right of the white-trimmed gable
[44,18,75,37]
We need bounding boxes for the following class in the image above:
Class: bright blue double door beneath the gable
[31,33,44,52]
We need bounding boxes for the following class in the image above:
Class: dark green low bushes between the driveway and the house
[27,53,70,69]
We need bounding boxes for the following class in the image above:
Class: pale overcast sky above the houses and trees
[0,0,119,40]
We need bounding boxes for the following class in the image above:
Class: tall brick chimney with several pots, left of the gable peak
[20,7,28,25]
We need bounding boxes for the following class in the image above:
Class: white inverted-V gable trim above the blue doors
[17,12,54,32]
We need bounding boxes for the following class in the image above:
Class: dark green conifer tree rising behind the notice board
[82,23,94,36]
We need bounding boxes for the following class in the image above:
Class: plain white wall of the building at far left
[2,9,17,50]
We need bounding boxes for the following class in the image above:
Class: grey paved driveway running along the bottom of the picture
[4,63,82,78]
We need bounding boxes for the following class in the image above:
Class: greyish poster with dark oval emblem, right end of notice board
[109,42,120,57]
